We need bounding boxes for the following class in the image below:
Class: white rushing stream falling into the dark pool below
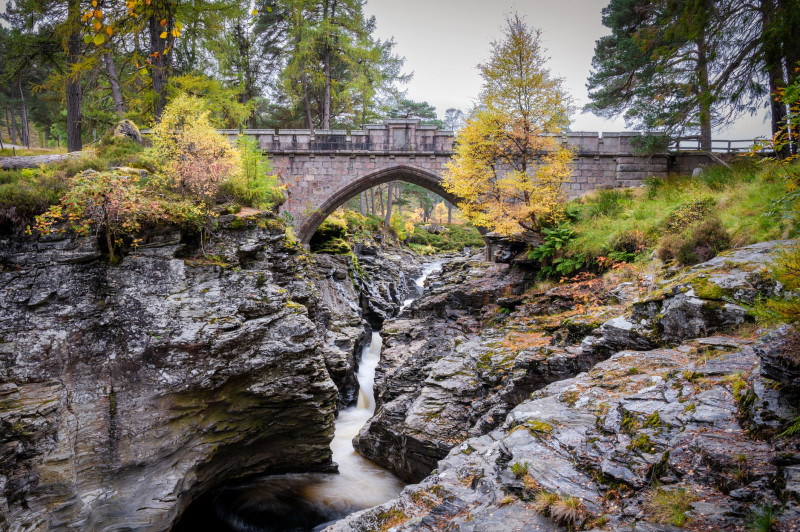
[175,261,442,532]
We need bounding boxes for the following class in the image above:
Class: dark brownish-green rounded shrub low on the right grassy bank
[656,216,731,266]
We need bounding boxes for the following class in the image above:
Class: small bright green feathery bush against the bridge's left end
[220,135,286,210]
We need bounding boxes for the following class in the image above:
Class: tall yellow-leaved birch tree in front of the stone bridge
[443,16,574,235]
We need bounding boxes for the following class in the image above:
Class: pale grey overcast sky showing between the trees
[364,0,769,139]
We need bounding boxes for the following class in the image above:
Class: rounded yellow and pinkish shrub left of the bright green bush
[152,95,241,204]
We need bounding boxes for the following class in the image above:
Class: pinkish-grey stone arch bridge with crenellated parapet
[220,119,708,244]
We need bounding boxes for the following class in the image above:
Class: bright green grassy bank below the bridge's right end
[566,161,798,259]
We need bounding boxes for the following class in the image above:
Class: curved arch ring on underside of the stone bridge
[296,164,460,245]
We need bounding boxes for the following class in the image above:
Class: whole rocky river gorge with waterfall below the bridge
[0,215,800,531]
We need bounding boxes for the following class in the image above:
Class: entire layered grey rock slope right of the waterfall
[340,243,800,531]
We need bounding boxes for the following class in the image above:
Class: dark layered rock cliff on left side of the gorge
[0,220,344,530]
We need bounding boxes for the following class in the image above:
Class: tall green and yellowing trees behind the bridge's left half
[0,0,463,151]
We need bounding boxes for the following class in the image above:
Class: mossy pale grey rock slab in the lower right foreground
[336,340,797,530]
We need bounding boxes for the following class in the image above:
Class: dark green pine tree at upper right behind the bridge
[586,0,768,145]
